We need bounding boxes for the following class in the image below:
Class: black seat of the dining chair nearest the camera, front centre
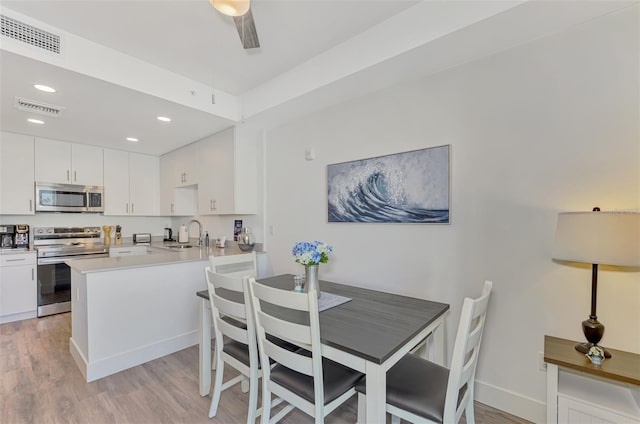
[271,358,363,404]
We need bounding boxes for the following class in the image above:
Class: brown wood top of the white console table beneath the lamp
[544,336,640,385]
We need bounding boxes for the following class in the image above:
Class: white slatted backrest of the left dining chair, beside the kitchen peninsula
[205,267,258,366]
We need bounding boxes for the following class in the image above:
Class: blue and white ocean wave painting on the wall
[327,145,449,224]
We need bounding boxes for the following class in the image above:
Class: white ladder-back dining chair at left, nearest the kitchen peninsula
[205,267,260,424]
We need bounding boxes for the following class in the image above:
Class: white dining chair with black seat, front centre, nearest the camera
[249,278,362,424]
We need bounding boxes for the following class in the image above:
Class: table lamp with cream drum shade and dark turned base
[553,208,640,358]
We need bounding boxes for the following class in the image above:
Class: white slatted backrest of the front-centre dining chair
[249,278,324,405]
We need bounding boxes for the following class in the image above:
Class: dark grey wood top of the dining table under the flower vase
[197,274,449,364]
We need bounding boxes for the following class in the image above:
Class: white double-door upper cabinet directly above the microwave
[35,138,103,186]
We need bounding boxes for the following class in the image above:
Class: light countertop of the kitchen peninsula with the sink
[65,242,259,274]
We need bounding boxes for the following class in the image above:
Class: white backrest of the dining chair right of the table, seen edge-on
[444,281,493,422]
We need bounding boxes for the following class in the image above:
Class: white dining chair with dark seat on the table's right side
[356,281,493,424]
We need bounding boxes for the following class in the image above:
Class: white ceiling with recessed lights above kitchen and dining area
[0,0,633,154]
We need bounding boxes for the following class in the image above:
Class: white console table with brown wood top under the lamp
[544,336,640,424]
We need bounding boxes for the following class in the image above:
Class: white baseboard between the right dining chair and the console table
[474,380,547,423]
